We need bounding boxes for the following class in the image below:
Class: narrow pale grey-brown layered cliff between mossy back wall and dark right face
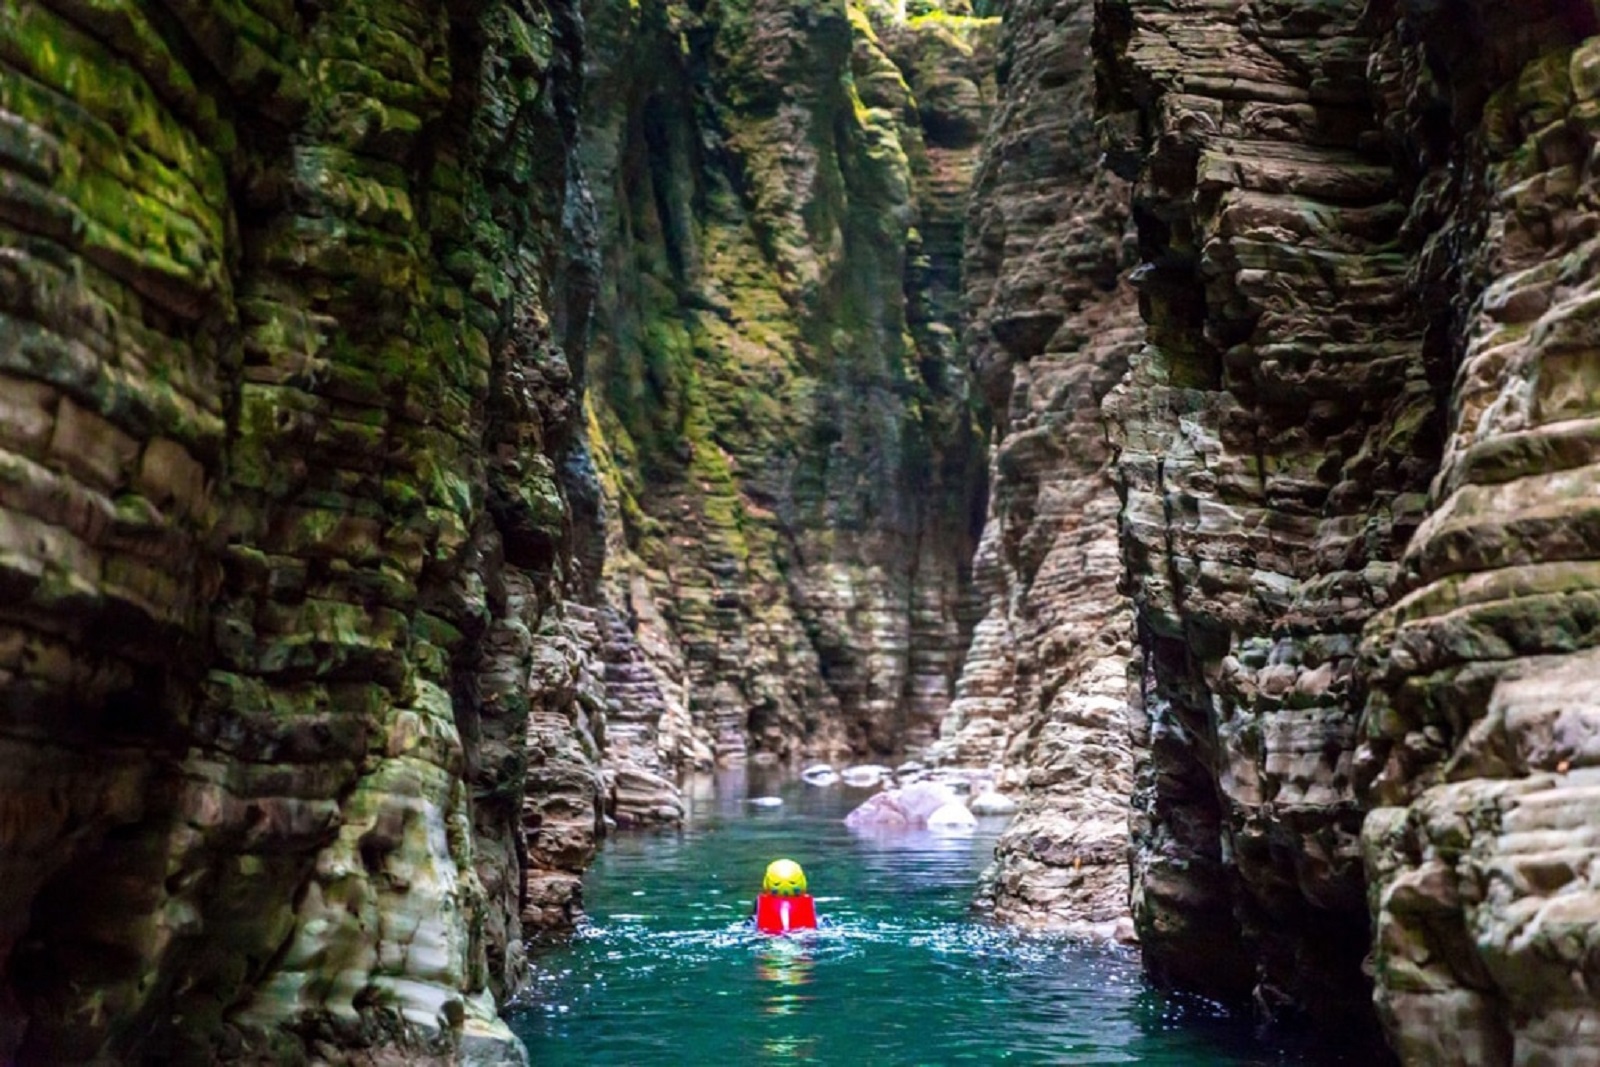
[936,0,1142,934]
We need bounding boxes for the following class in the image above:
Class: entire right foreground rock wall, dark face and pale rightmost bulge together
[1096,0,1600,1064]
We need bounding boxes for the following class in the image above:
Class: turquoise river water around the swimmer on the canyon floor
[510,773,1337,1067]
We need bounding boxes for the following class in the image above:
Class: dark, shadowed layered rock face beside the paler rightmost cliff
[1096,0,1438,1033]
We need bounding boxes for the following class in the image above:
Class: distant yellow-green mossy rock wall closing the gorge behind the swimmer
[584,0,994,768]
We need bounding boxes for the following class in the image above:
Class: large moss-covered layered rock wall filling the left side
[0,0,602,1062]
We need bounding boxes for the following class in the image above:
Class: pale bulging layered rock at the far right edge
[1362,2,1600,1064]
